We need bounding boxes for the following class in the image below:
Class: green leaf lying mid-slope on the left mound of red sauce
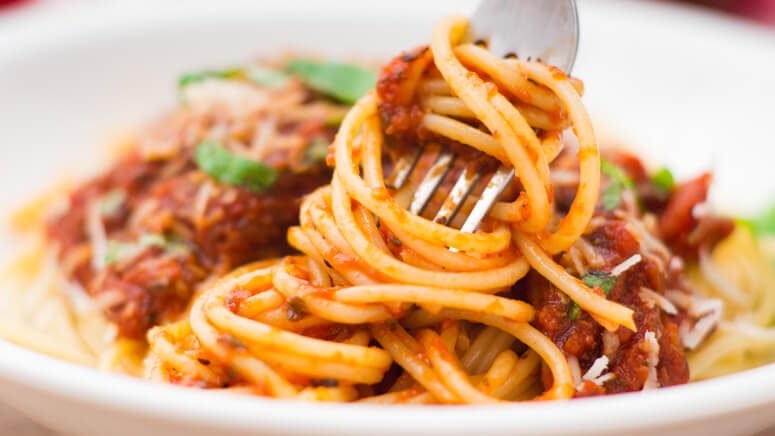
[194,142,277,191]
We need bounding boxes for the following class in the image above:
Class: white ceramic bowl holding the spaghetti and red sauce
[0,0,775,436]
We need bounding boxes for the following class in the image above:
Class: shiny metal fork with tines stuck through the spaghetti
[387,0,579,237]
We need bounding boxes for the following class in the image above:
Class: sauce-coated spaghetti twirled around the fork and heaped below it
[147,16,656,403]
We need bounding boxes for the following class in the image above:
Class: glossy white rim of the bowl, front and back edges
[0,0,775,434]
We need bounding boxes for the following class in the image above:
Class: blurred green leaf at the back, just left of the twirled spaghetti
[287,59,377,103]
